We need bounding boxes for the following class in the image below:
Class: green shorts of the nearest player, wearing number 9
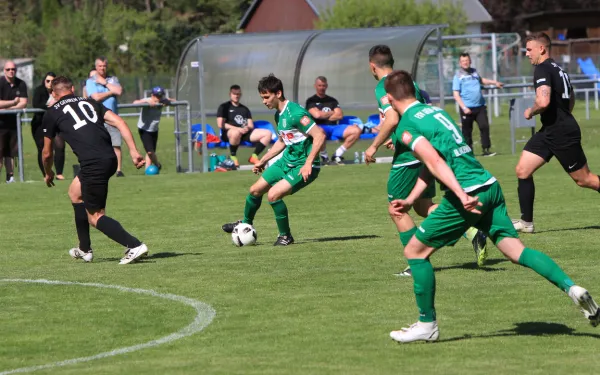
[415,182,519,249]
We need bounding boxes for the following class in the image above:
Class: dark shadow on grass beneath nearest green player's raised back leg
[437,322,600,342]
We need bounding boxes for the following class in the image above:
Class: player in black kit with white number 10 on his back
[42,77,148,264]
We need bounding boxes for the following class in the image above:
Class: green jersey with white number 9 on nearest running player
[397,101,496,193]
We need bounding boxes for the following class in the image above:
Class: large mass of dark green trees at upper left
[0,0,251,77]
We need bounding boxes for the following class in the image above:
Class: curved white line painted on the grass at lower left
[0,279,216,375]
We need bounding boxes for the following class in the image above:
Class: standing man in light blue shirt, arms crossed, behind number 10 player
[85,56,125,177]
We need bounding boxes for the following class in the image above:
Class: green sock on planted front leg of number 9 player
[408,259,436,322]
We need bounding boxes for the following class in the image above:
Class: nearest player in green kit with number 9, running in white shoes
[385,71,600,342]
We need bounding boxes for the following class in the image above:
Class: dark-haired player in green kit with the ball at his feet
[223,74,325,246]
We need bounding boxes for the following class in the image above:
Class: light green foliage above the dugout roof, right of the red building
[316,0,467,34]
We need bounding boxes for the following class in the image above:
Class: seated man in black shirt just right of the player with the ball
[305,76,361,164]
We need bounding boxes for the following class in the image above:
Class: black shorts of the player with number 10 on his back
[77,157,117,211]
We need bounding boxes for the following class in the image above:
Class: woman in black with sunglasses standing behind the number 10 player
[31,72,65,180]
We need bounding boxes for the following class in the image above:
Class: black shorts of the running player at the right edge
[524,131,587,173]
